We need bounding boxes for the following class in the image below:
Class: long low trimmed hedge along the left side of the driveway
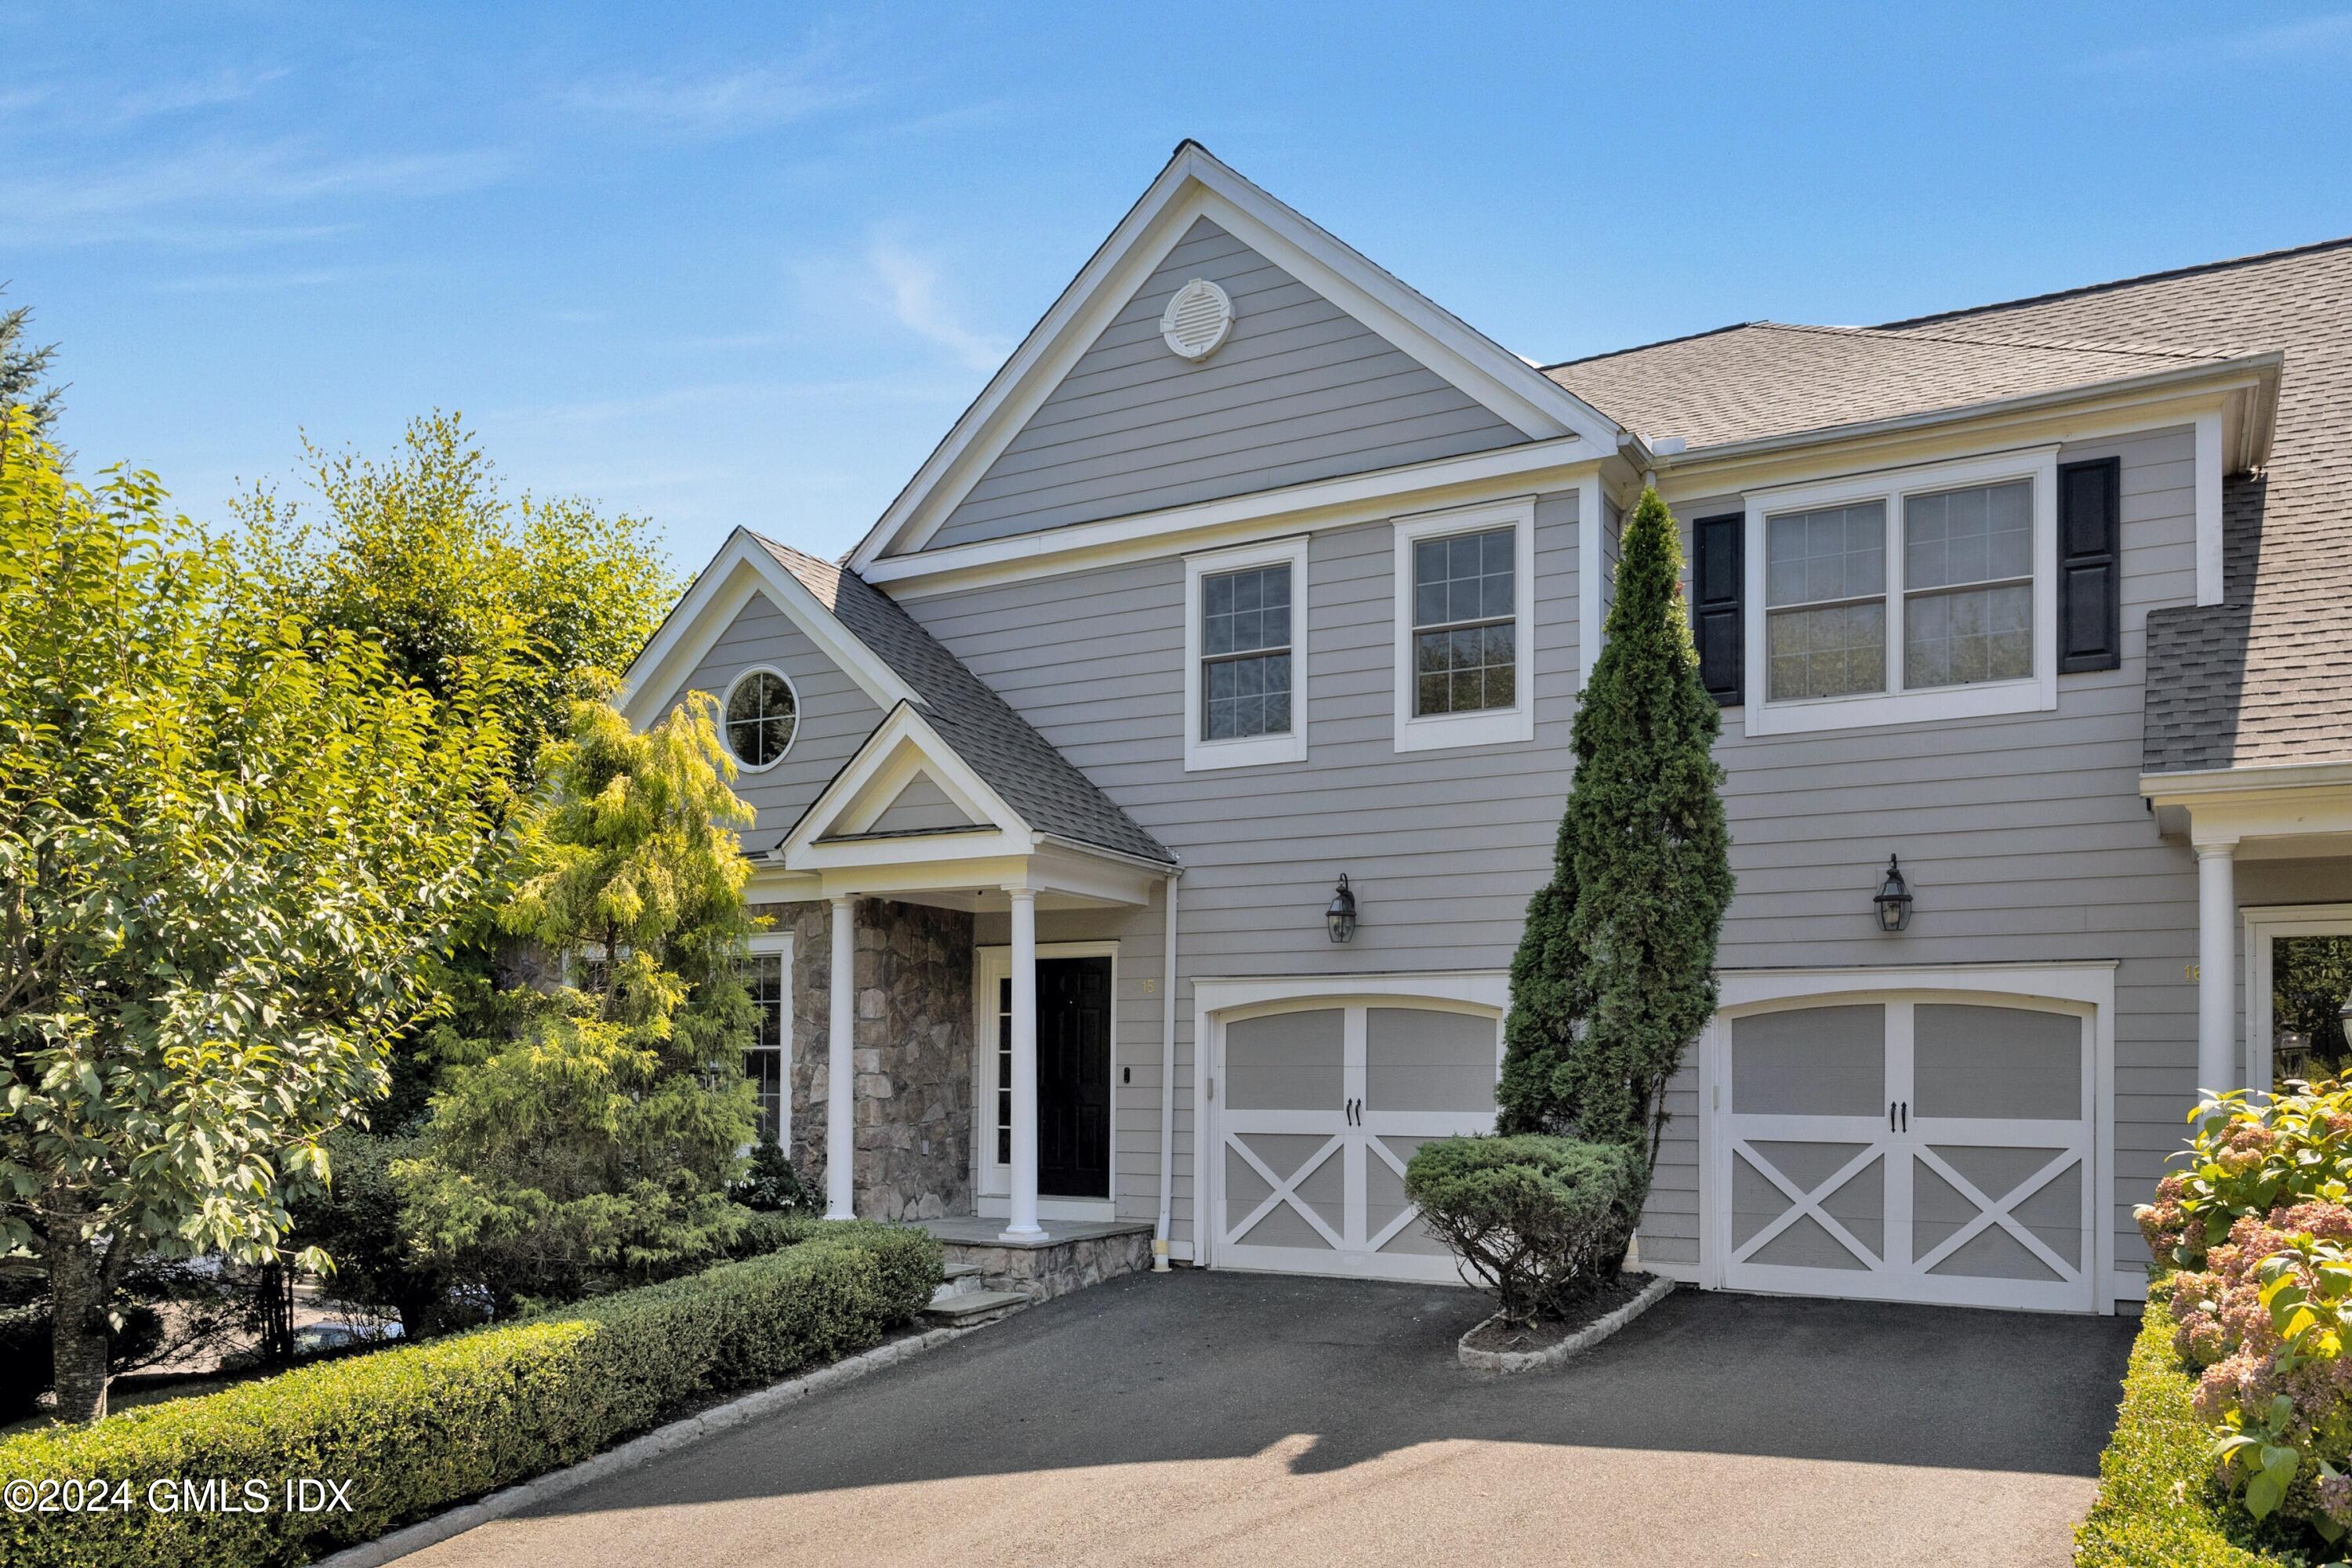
[0,1222,941,1568]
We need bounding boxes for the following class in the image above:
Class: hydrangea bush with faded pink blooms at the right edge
[2136,1083,2352,1542]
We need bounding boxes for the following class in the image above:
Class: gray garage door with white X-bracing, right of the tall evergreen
[1712,996,2096,1312]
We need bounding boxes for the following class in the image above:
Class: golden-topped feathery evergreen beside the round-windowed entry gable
[393,694,755,1307]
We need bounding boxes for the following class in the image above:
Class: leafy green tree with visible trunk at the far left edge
[0,416,506,1417]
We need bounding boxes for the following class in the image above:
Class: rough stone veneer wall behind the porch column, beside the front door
[753,898,971,1220]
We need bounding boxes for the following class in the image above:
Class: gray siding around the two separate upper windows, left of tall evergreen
[906,494,1576,1239]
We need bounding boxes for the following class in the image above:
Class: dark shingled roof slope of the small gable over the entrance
[755,534,1176,865]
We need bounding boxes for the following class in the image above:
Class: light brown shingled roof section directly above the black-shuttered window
[1543,322,2267,449]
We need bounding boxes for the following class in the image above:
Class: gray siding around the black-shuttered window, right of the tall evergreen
[1642,430,2201,1269]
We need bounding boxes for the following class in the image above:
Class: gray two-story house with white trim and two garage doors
[626,143,2352,1312]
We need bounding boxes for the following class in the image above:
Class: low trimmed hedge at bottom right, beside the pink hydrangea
[2074,1288,2303,1568]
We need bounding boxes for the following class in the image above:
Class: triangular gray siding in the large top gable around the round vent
[931,219,1524,548]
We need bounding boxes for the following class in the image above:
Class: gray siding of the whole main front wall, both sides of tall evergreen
[908,430,2239,1298]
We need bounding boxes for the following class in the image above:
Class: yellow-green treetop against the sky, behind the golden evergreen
[233,414,677,799]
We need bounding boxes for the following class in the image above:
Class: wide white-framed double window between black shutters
[1745,447,2058,734]
